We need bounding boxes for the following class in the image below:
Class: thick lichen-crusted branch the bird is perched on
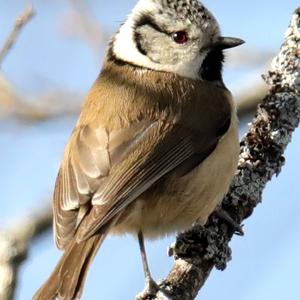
[138,8,300,300]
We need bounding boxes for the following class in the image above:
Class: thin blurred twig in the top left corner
[0,6,34,67]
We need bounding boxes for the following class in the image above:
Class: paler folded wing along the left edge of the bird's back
[53,122,149,249]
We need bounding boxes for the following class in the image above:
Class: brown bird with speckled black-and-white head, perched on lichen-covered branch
[33,0,244,300]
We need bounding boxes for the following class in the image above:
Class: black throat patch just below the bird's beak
[200,50,224,81]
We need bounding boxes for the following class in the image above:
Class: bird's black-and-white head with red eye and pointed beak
[110,0,243,81]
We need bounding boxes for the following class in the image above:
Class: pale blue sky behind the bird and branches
[0,0,300,300]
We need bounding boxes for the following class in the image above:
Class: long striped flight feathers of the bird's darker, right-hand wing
[78,131,194,240]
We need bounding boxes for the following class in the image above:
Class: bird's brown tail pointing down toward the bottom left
[33,235,105,300]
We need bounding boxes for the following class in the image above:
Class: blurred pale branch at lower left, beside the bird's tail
[0,206,52,300]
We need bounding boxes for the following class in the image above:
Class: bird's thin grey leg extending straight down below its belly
[138,231,159,298]
